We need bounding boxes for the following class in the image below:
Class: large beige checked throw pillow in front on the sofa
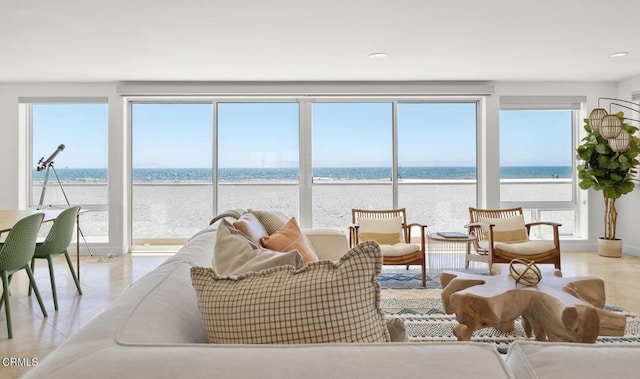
[191,241,390,344]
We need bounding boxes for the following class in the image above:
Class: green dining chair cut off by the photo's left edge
[0,213,48,339]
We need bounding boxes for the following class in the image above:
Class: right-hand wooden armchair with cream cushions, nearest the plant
[465,207,561,271]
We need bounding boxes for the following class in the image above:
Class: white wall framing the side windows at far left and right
[0,81,640,255]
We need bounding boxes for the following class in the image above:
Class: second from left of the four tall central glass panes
[217,103,299,216]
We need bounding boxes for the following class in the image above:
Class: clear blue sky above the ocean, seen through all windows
[33,103,573,168]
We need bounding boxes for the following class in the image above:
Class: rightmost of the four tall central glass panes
[398,102,477,231]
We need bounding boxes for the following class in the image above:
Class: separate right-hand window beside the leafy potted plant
[500,109,577,235]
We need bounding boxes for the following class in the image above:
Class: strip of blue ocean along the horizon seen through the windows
[33,166,572,183]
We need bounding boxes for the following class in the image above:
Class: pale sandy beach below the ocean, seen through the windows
[34,181,574,241]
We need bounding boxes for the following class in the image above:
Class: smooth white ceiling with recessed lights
[0,0,640,82]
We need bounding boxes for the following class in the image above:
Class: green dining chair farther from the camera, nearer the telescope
[29,207,82,311]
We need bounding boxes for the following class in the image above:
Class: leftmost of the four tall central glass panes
[131,103,213,244]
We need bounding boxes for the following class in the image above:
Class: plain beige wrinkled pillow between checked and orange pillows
[212,220,302,275]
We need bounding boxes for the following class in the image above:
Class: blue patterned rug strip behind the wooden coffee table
[378,268,489,289]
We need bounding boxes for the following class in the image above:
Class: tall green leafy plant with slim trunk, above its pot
[577,112,640,240]
